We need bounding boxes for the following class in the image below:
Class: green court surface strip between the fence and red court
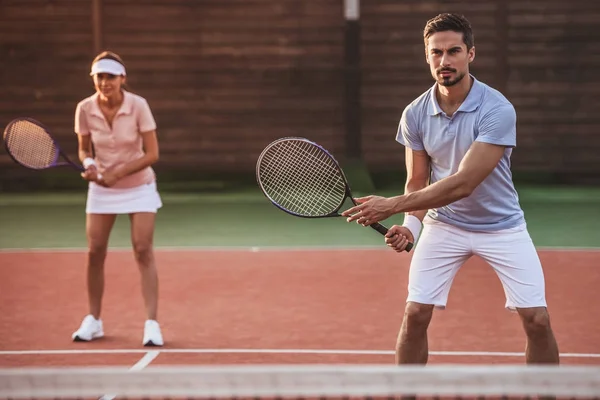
[0,186,600,249]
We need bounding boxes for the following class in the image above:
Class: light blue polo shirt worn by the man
[396,77,525,231]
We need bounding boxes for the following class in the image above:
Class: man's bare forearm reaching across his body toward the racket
[392,175,471,216]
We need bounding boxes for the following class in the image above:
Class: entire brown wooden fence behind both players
[0,0,600,188]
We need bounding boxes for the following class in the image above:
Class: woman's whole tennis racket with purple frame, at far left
[4,118,101,177]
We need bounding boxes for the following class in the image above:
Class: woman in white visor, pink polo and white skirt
[73,52,163,346]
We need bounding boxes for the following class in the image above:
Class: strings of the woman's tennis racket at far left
[4,120,58,169]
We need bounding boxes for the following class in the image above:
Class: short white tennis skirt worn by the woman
[85,182,162,214]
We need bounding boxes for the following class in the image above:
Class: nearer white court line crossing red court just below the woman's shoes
[0,349,600,358]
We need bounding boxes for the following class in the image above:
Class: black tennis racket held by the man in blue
[256,137,413,251]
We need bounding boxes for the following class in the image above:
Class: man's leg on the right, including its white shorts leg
[473,225,559,364]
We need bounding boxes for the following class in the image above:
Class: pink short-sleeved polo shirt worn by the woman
[75,91,156,188]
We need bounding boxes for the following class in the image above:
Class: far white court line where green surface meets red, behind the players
[0,245,600,254]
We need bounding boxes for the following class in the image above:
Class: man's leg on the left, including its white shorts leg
[396,218,471,364]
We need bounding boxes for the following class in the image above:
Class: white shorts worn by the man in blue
[407,217,546,311]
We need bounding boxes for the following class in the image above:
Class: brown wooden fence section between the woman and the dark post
[94,0,343,173]
